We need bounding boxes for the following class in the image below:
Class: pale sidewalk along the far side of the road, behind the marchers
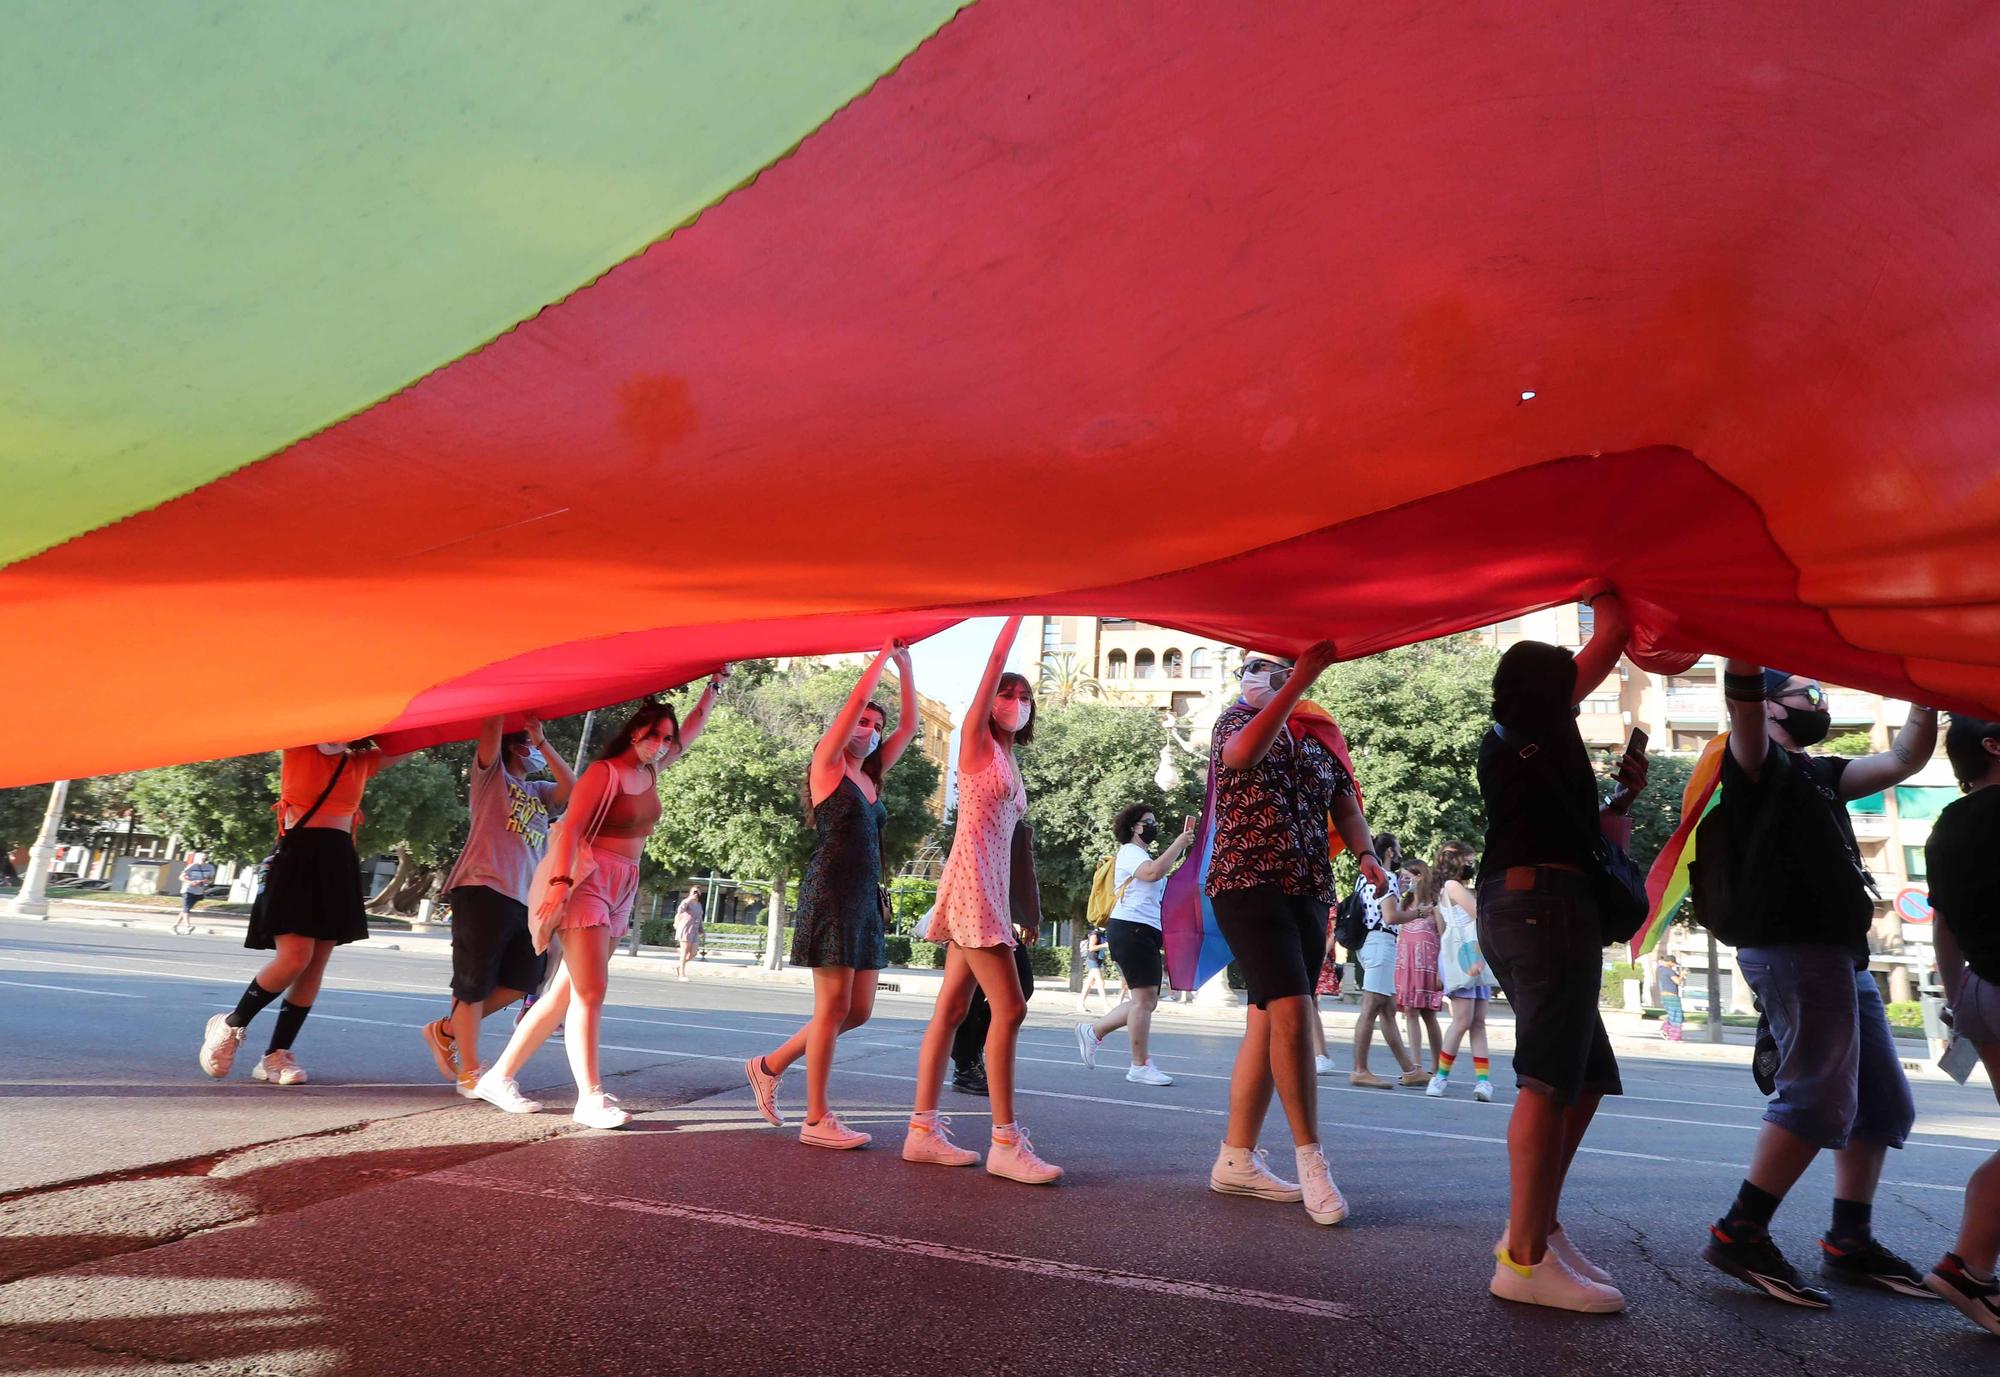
[31,899,1978,1081]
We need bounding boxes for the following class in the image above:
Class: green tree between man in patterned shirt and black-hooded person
[1312,636,1500,865]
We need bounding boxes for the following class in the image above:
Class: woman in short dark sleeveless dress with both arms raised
[744,640,916,1147]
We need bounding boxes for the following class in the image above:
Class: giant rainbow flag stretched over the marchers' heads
[0,0,2000,785]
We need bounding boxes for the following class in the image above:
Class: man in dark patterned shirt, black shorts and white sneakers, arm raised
[1204,640,1388,1225]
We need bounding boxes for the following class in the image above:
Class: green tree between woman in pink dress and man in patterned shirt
[1020,703,1204,921]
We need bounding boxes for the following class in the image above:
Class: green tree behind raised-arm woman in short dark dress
[646,664,938,877]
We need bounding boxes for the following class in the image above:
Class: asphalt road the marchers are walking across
[0,921,2000,1377]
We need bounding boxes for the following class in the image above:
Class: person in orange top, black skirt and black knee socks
[196,741,402,1085]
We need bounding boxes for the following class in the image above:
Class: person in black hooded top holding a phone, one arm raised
[1478,594,1646,1313]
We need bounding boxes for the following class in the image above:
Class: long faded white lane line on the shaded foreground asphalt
[420,1171,1354,1319]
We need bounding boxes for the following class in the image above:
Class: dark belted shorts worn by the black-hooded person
[1478,867,1624,1105]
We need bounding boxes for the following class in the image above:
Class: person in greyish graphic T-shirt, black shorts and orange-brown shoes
[424,717,576,1099]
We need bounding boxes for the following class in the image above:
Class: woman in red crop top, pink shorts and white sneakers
[472,668,728,1129]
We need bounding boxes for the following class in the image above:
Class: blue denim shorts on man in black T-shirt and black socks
[1736,945,1916,1149]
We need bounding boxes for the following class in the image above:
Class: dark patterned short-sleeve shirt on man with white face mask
[1208,703,1354,905]
